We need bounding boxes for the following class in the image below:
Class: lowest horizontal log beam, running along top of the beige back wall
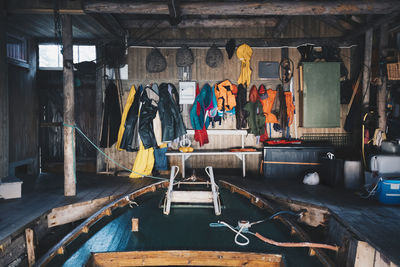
[129,37,356,47]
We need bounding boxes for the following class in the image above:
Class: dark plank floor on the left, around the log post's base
[0,174,158,244]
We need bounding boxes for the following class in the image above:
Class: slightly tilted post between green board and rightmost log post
[362,28,374,106]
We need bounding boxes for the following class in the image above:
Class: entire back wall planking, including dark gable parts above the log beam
[101,20,350,176]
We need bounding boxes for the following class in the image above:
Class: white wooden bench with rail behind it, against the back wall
[166,130,262,178]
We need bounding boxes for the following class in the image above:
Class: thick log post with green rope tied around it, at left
[61,15,76,196]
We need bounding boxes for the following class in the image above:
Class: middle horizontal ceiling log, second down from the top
[121,18,277,28]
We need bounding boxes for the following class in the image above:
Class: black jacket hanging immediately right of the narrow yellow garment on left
[120,86,142,152]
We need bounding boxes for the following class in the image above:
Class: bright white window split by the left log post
[39,44,96,69]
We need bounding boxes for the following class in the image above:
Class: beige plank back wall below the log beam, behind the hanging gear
[101,44,350,174]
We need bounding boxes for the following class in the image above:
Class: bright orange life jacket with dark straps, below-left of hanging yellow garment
[215,80,238,111]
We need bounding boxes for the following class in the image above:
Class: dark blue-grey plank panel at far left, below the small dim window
[8,39,39,166]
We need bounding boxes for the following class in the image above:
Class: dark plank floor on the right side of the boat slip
[224,177,400,266]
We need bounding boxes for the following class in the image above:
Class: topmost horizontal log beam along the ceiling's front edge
[83,0,399,16]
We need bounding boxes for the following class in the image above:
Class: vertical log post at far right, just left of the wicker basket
[377,24,388,132]
